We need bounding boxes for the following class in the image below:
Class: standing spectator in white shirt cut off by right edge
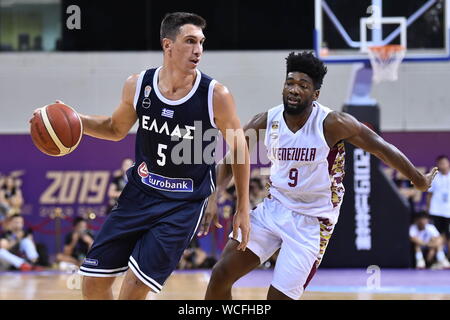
[427,156,450,253]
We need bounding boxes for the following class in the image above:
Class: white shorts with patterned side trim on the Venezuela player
[230,198,333,299]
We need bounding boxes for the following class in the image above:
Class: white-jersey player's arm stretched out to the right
[324,112,437,191]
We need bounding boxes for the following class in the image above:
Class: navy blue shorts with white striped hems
[79,183,207,292]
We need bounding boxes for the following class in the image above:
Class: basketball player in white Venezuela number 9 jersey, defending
[203,52,436,299]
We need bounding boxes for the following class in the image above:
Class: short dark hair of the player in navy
[160,12,206,40]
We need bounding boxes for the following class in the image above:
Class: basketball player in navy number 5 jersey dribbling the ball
[67,12,250,299]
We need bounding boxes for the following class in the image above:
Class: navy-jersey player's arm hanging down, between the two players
[213,83,250,250]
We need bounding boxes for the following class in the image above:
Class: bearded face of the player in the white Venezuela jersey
[283,72,319,115]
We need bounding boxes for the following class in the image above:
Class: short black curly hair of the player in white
[286,51,328,90]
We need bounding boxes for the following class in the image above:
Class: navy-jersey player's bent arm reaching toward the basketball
[80,74,139,141]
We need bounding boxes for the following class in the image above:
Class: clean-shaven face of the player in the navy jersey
[169,24,205,70]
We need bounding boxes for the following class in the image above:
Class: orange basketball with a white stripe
[30,103,83,157]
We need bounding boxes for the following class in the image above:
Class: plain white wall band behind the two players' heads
[0,51,450,133]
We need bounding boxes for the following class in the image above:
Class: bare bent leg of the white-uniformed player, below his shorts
[205,239,261,300]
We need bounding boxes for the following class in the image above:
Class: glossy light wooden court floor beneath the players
[0,271,450,300]
